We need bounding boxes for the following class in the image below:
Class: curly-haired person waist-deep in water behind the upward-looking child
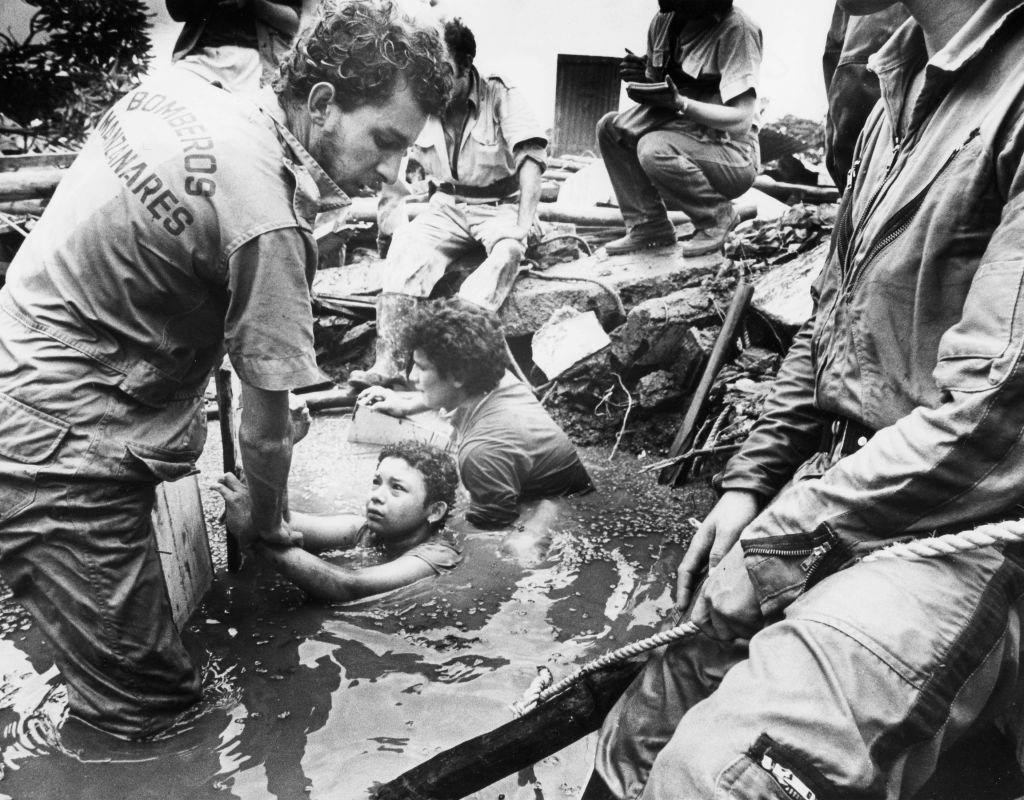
[359,298,591,529]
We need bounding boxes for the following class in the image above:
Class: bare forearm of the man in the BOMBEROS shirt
[239,381,299,543]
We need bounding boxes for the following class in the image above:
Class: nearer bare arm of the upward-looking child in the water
[256,543,434,602]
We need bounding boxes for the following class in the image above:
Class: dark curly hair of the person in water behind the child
[402,297,506,394]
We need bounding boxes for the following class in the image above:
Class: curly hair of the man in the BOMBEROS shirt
[274,0,453,116]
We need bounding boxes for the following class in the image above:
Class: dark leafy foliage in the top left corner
[0,0,152,146]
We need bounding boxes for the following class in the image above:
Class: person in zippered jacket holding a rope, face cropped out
[585,0,1024,800]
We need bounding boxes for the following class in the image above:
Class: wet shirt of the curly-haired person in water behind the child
[452,373,591,528]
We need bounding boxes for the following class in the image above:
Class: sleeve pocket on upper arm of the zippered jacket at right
[933,261,1024,391]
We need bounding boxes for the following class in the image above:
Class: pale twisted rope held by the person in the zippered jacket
[512,519,1024,716]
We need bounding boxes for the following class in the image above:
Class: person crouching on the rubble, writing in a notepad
[597,0,761,256]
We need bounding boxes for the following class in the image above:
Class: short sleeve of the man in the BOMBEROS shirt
[224,227,321,391]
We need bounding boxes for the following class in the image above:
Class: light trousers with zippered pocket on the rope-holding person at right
[596,549,1024,800]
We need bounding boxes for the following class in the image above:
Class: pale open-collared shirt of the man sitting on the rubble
[409,68,548,194]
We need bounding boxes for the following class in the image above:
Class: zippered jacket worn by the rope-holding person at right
[720,0,1024,547]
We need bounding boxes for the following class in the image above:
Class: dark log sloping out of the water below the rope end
[373,660,643,800]
